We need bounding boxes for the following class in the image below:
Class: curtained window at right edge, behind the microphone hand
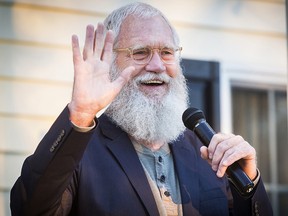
[232,87,288,215]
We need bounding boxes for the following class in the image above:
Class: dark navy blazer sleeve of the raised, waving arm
[10,107,95,215]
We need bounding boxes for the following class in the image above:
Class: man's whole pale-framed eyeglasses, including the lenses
[113,47,182,64]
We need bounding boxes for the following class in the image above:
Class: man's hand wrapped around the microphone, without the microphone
[200,133,257,180]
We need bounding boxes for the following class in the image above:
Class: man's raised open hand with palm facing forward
[68,23,135,127]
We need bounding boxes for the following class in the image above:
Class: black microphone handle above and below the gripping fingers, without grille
[194,120,254,195]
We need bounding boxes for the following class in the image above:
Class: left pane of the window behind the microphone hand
[232,87,271,182]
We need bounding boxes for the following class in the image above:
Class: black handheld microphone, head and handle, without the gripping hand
[182,107,254,195]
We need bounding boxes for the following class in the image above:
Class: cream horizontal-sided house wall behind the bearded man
[0,0,287,216]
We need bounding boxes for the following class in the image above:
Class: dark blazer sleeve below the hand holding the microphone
[230,177,273,216]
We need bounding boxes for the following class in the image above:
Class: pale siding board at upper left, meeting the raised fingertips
[0,7,103,46]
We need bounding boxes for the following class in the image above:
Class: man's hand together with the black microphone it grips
[182,107,257,195]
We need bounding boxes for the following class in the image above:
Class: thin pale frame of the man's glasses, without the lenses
[113,46,182,65]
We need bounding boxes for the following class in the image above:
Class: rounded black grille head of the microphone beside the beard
[182,107,205,130]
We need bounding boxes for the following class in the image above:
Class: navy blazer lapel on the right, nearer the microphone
[171,134,200,215]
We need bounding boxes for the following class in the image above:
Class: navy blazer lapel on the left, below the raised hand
[100,115,159,216]
